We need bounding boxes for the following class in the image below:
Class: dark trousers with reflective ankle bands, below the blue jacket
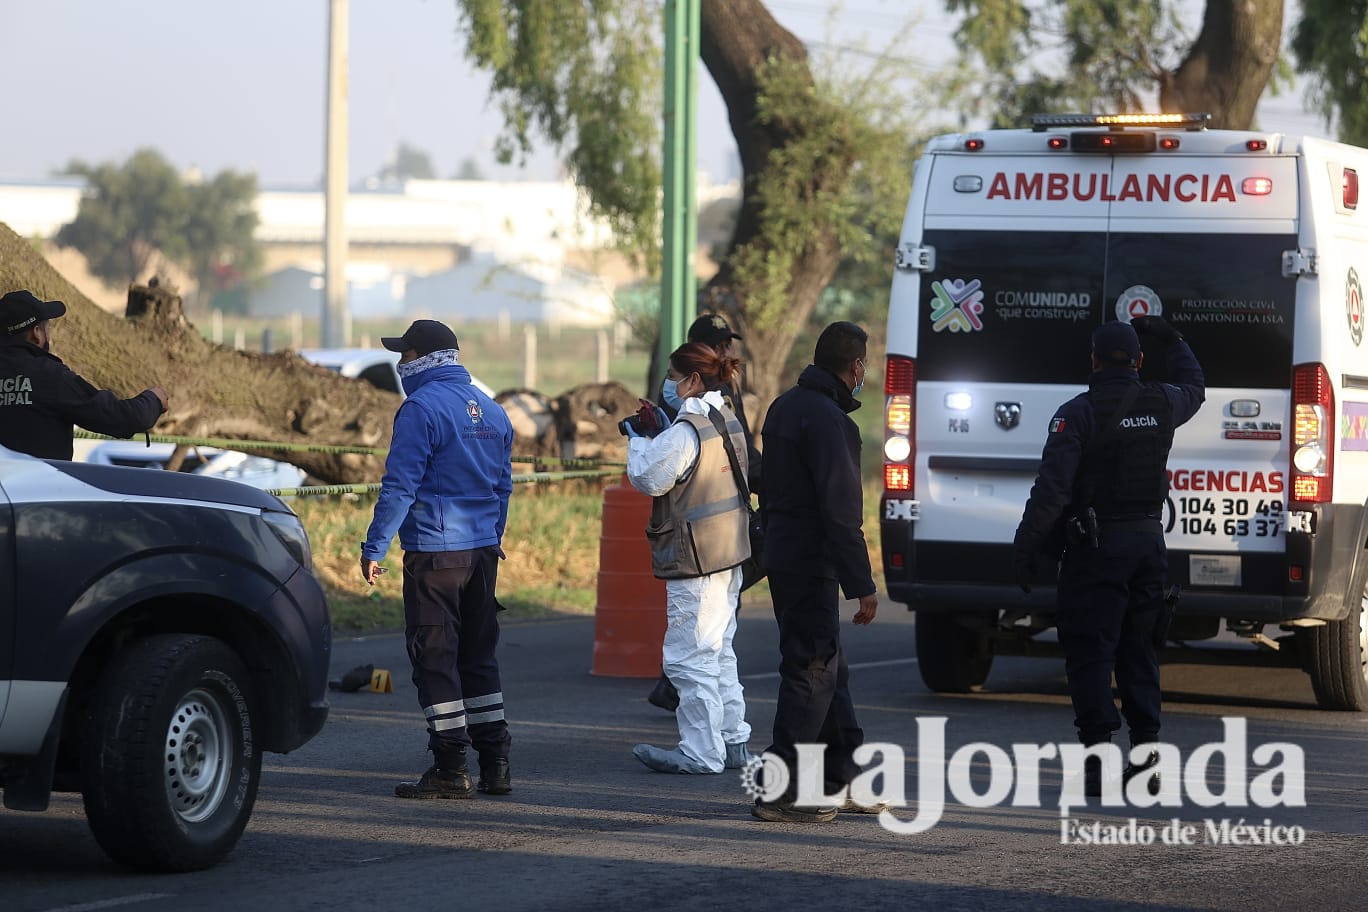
[404,547,512,766]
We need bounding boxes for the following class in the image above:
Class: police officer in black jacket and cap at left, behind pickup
[0,291,170,459]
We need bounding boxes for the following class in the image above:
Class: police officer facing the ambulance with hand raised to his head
[1014,317,1205,796]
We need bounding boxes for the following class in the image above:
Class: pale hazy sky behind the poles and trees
[0,0,1324,187]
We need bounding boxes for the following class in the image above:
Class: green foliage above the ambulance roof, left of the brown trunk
[945,0,1192,127]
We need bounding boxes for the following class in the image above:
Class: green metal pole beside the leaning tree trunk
[653,0,699,374]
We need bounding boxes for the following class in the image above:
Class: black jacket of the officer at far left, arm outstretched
[0,336,161,459]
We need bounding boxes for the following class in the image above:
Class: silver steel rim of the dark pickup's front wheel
[166,689,231,823]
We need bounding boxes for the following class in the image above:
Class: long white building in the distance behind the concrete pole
[0,172,740,325]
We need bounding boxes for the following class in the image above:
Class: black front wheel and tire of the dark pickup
[81,634,261,871]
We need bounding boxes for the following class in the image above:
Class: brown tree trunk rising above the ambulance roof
[1159,0,1283,130]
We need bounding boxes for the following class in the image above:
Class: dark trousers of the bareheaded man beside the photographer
[769,573,865,799]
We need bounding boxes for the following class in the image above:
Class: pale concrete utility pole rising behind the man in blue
[323,0,352,349]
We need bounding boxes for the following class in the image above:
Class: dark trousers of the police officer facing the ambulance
[1057,526,1168,744]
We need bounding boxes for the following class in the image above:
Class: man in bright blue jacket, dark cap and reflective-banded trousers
[361,320,513,799]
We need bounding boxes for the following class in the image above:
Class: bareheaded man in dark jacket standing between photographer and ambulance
[752,323,878,823]
